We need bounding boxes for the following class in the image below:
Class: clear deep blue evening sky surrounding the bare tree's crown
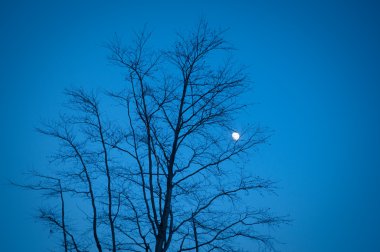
[0,0,380,252]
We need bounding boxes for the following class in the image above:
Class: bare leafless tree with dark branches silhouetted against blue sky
[17,21,285,252]
